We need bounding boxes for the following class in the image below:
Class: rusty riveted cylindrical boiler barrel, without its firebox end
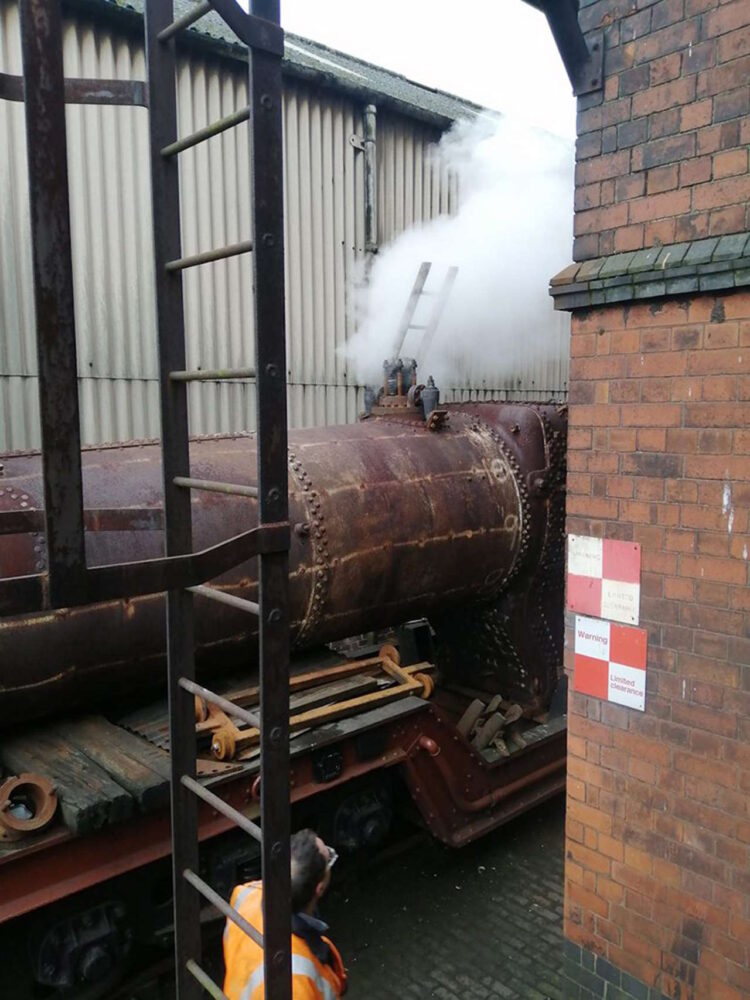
[0,404,554,726]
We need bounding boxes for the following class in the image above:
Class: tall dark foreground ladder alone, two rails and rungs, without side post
[146,0,291,1000]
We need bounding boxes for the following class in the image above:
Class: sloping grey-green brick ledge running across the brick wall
[549,232,750,310]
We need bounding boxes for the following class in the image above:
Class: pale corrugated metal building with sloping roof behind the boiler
[0,0,567,451]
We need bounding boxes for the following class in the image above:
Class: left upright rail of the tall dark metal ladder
[145,0,201,1000]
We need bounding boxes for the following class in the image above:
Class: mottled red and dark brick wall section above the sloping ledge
[573,0,750,260]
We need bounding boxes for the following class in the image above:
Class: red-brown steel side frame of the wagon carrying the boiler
[0,698,565,923]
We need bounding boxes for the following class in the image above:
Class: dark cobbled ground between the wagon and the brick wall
[323,798,564,1000]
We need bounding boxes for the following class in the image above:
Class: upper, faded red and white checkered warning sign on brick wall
[567,535,641,625]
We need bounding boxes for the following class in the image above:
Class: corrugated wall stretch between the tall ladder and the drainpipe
[284,74,365,427]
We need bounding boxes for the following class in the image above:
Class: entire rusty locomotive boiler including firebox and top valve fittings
[0,378,566,728]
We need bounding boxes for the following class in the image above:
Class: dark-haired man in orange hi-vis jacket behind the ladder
[224,830,346,1000]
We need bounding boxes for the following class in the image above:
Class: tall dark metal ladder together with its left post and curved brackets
[11,0,291,1000]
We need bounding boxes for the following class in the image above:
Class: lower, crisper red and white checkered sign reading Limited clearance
[573,615,646,712]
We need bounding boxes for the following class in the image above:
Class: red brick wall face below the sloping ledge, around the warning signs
[566,286,750,1000]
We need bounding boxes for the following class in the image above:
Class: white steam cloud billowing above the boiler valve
[344,116,573,394]
